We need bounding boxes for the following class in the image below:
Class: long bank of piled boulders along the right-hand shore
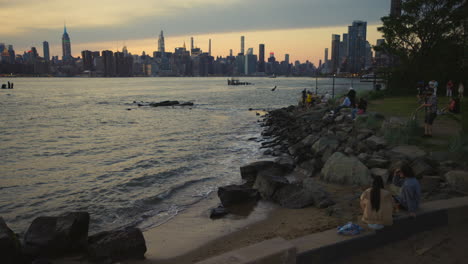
[211,105,468,218]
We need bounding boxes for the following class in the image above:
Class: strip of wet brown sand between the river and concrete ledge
[130,184,362,264]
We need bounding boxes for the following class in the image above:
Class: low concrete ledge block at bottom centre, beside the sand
[197,237,296,264]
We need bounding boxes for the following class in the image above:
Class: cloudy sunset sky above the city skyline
[0,0,390,63]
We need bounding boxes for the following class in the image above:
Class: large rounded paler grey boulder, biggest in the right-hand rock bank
[321,152,371,185]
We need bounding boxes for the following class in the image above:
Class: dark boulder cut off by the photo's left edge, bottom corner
[0,217,21,264]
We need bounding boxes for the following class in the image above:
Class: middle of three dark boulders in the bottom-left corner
[24,212,89,257]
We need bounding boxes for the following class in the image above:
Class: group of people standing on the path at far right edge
[416,80,464,137]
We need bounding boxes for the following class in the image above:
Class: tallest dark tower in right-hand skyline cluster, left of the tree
[347,21,367,73]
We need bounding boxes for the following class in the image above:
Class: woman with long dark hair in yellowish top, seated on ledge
[360,176,393,229]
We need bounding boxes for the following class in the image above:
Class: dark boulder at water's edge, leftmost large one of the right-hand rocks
[218,184,259,207]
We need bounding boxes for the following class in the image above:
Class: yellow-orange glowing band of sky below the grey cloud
[49,24,382,66]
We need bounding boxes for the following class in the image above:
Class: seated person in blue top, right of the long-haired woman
[392,164,421,217]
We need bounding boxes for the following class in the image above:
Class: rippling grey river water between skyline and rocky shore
[0,78,371,233]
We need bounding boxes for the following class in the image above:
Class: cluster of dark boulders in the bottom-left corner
[0,212,146,264]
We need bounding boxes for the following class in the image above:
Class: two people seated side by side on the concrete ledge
[361,164,421,229]
